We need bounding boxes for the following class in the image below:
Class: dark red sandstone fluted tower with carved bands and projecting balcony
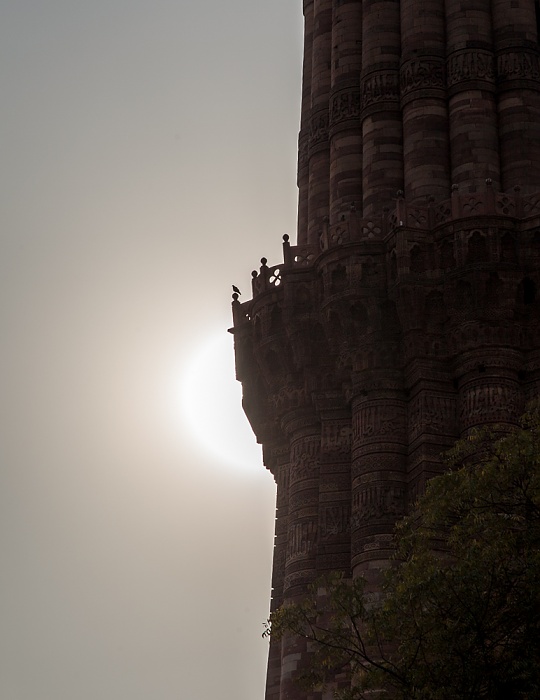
[232,0,540,700]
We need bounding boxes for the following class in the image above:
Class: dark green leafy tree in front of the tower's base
[268,408,540,700]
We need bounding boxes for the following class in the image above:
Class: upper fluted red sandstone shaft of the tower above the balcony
[298,0,540,244]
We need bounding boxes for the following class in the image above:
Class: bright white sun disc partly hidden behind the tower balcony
[176,330,262,470]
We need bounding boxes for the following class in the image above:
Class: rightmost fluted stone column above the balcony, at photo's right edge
[492,0,540,192]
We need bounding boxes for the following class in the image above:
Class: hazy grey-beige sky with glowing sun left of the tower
[0,0,302,700]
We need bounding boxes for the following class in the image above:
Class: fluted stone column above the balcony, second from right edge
[446,0,501,192]
